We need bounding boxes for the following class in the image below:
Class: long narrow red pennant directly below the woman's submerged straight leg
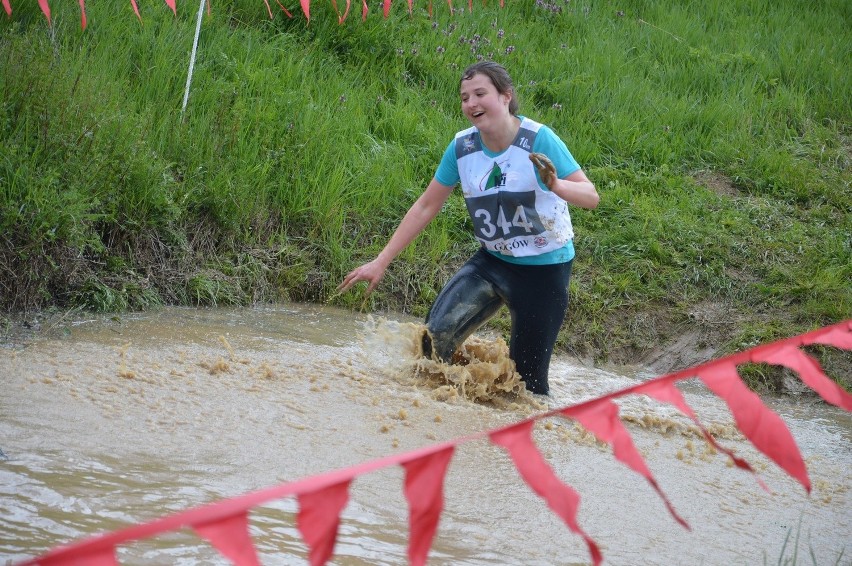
[489,421,603,565]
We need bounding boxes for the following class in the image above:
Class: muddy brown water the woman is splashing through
[0,304,852,565]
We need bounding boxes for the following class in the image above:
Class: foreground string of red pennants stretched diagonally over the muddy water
[13,322,852,566]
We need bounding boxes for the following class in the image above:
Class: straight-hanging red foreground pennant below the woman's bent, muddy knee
[402,446,455,566]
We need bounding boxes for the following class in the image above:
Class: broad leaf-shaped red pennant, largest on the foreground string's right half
[698,363,811,493]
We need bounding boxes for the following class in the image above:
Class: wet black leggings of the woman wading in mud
[423,249,573,395]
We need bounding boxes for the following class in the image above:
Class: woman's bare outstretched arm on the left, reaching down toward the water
[337,179,453,295]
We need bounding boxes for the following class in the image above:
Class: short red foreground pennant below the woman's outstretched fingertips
[296,479,352,566]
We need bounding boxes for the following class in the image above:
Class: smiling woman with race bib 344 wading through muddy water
[338,58,600,395]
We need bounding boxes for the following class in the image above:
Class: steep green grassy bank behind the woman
[0,0,852,385]
